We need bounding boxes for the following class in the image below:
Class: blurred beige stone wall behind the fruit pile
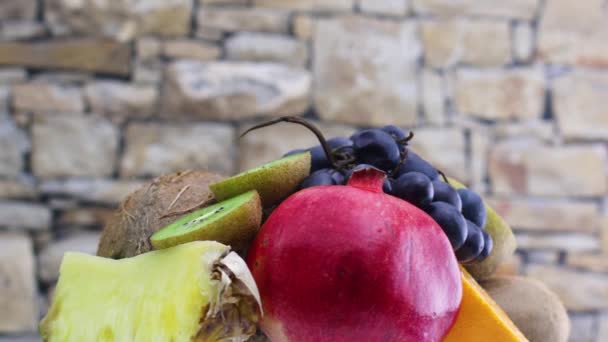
[0,0,608,342]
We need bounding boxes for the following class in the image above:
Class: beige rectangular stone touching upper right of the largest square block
[421,19,511,68]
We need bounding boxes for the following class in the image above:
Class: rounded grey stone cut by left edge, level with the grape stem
[0,112,30,177]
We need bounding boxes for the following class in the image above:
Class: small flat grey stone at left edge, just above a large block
[0,201,51,231]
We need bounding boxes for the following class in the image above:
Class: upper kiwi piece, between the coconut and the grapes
[209,152,310,208]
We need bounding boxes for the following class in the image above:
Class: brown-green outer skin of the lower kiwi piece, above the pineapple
[150,191,262,253]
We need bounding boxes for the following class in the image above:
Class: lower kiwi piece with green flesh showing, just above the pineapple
[150,190,262,251]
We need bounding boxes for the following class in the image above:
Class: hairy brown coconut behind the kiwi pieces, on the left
[97,171,223,259]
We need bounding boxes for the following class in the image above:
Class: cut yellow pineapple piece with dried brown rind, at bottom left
[40,241,261,342]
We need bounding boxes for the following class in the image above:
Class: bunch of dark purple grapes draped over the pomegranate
[287,125,493,264]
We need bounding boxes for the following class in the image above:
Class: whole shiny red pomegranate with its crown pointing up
[248,168,462,342]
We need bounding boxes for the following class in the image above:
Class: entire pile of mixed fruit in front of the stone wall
[40,117,568,342]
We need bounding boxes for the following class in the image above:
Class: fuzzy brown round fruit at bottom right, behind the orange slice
[480,277,570,342]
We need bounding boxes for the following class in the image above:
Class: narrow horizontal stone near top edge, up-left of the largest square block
[197,7,289,33]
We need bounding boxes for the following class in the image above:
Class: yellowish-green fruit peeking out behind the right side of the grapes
[448,178,517,280]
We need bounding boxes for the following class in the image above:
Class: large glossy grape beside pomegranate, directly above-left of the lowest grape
[426,202,467,250]
